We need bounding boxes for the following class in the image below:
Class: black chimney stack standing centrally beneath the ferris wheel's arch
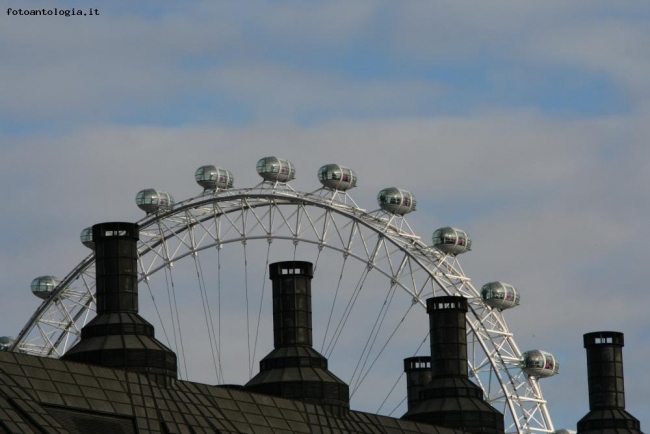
[244,261,350,414]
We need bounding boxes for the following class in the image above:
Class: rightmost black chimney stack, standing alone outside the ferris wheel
[578,332,641,434]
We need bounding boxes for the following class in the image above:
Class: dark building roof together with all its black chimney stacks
[5,222,642,434]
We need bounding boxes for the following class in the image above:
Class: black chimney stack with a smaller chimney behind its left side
[402,296,504,434]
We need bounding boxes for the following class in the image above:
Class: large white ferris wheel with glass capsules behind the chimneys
[7,157,559,433]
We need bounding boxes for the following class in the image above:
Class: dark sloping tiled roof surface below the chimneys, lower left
[0,352,460,434]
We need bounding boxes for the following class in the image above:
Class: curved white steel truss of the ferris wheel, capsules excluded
[11,164,554,433]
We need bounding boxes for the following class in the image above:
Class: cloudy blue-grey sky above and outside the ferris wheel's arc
[0,0,650,430]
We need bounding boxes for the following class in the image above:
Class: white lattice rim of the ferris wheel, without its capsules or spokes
[10,182,554,433]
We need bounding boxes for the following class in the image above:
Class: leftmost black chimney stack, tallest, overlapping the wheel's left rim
[61,222,177,385]
